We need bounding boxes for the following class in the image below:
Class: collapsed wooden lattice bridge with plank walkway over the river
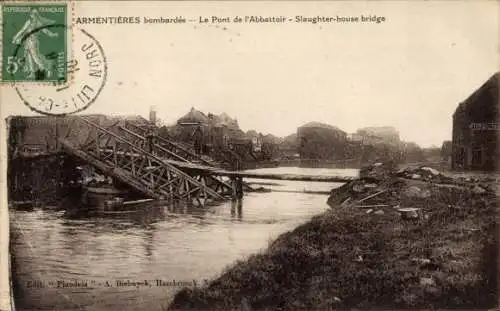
[59,117,354,204]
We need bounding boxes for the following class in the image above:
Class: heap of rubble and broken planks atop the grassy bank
[327,163,494,219]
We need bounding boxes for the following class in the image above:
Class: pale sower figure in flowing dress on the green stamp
[12,9,58,78]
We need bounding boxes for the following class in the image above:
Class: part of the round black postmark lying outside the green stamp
[14,25,108,115]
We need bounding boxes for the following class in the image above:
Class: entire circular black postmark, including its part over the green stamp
[11,24,108,116]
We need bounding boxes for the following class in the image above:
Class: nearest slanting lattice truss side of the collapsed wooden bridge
[59,118,224,202]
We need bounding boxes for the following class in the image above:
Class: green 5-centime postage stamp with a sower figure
[1,2,68,83]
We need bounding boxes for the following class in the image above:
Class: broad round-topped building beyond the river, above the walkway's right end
[297,122,347,160]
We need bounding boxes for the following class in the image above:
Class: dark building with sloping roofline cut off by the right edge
[451,72,500,171]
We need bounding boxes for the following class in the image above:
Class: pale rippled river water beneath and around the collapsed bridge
[10,167,357,311]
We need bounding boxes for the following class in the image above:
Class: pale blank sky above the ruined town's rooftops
[0,1,500,147]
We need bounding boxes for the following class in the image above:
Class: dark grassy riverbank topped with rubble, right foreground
[168,170,497,310]
